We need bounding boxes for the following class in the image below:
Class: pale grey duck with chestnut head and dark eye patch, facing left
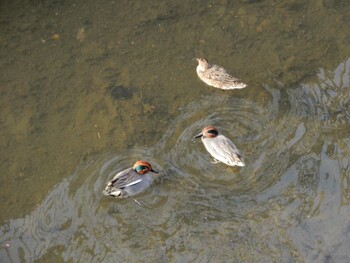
[195,126,244,166]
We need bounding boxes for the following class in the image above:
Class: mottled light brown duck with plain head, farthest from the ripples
[197,58,247,90]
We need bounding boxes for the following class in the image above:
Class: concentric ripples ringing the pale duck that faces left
[157,87,292,198]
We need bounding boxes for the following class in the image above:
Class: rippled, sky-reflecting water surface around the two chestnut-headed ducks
[0,59,350,262]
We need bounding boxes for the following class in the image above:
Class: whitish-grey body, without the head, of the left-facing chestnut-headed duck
[202,134,245,166]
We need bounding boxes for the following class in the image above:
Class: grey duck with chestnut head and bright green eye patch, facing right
[103,161,158,198]
